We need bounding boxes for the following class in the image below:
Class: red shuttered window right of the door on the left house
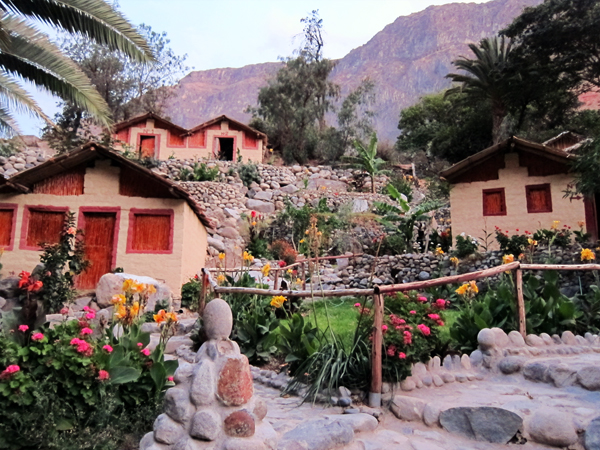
[127,209,173,253]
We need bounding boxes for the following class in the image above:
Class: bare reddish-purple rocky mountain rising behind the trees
[166,0,541,142]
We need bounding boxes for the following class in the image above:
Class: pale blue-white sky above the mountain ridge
[17,0,488,135]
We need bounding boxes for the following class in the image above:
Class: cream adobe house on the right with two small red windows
[440,137,598,249]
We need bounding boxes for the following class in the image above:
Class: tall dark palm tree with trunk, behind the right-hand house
[445,37,512,144]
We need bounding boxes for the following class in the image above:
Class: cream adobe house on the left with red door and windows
[0,143,211,294]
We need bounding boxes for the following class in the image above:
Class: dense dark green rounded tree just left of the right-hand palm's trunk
[395,91,492,162]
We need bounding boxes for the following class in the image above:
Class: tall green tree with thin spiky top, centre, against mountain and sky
[249,11,339,162]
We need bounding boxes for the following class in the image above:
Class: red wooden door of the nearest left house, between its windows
[77,213,117,289]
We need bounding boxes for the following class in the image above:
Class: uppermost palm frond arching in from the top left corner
[0,0,154,62]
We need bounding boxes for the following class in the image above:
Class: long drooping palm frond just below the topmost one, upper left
[0,17,112,127]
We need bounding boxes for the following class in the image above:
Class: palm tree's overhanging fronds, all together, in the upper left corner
[0,0,153,134]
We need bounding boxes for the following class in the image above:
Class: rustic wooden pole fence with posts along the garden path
[199,255,600,407]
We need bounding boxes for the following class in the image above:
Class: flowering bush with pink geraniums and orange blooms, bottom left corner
[0,280,177,450]
